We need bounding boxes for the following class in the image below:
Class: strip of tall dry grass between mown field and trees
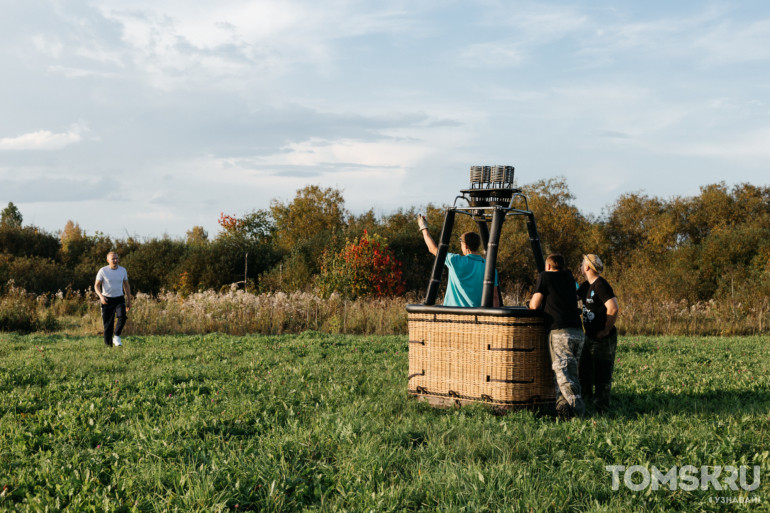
[0,285,770,335]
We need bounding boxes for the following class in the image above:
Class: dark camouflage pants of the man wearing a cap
[580,331,618,411]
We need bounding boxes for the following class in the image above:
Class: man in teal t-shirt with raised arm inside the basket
[417,216,500,307]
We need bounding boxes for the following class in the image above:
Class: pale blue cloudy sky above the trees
[0,0,770,238]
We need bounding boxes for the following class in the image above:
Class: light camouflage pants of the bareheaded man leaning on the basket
[548,328,585,416]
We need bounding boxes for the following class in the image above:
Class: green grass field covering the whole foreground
[0,332,770,512]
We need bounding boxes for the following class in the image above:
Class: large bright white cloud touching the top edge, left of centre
[85,0,420,90]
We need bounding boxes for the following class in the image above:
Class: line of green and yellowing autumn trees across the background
[0,178,770,315]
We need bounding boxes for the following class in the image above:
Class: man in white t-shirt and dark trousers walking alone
[94,251,131,347]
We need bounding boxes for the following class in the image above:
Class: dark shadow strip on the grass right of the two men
[607,390,770,417]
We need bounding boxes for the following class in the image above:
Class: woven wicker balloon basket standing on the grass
[407,305,555,409]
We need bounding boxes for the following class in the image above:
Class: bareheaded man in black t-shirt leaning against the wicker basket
[529,255,585,418]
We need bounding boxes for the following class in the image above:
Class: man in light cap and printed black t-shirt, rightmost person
[577,255,618,413]
